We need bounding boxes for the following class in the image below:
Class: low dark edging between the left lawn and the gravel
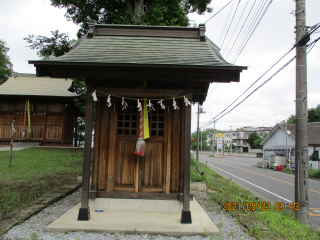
[0,182,81,235]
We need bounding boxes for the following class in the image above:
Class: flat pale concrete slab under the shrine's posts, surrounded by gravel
[46,200,219,236]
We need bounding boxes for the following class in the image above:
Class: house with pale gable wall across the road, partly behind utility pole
[260,122,320,164]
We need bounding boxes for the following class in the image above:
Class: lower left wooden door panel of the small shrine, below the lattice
[114,141,136,188]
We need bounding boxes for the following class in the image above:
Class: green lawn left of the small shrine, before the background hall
[0,148,83,219]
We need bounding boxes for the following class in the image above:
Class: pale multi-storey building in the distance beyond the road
[207,126,271,153]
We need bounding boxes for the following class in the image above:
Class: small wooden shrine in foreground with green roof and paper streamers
[29,22,246,223]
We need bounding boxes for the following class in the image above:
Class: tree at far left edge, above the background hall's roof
[0,39,14,85]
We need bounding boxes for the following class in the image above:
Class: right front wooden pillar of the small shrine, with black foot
[181,81,192,223]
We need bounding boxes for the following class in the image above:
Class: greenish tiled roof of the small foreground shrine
[30,25,246,69]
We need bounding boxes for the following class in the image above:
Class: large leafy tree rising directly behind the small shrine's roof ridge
[51,0,212,38]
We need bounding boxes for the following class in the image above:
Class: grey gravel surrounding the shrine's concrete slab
[0,188,254,240]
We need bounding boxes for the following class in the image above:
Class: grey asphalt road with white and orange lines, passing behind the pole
[199,154,320,226]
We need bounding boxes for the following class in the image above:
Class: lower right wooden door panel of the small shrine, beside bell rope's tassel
[142,141,164,188]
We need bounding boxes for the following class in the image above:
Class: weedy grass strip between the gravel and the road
[191,157,320,239]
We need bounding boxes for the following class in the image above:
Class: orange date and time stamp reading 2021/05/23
[222,202,299,211]
